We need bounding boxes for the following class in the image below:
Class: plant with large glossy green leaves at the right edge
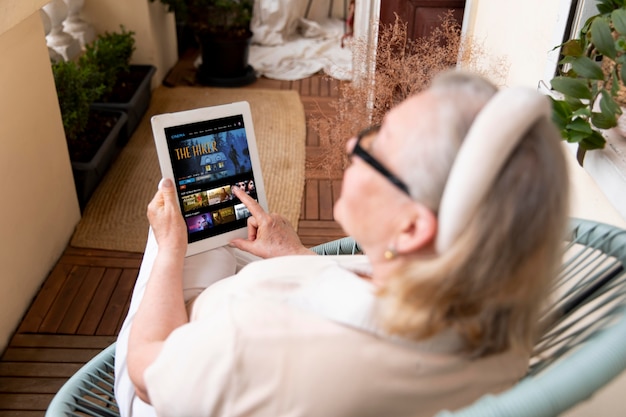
[551,0,626,165]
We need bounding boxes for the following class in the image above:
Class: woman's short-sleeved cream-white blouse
[144,256,528,417]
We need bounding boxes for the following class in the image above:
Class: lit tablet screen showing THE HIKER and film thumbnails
[164,115,257,243]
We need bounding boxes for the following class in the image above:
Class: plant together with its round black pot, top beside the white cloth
[150,0,256,87]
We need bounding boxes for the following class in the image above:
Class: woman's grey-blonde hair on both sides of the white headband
[381,72,569,356]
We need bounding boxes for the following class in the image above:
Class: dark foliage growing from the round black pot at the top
[150,0,254,38]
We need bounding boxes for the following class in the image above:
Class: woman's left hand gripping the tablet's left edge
[148,178,187,254]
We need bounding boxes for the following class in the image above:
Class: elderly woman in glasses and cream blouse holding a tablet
[116,72,568,417]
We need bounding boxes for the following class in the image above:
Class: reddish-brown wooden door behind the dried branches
[380,0,465,39]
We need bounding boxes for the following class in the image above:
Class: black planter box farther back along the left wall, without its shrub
[92,65,156,141]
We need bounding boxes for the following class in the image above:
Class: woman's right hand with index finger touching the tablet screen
[231,187,315,258]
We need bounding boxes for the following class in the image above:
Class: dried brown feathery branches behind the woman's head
[308,11,507,172]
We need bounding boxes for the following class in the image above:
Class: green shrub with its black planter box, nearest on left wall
[52,61,126,208]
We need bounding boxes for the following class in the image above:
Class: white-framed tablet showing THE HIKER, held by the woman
[151,101,267,256]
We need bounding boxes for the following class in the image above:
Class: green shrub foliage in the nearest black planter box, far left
[52,61,105,143]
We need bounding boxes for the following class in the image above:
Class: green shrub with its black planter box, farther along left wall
[86,26,156,144]
